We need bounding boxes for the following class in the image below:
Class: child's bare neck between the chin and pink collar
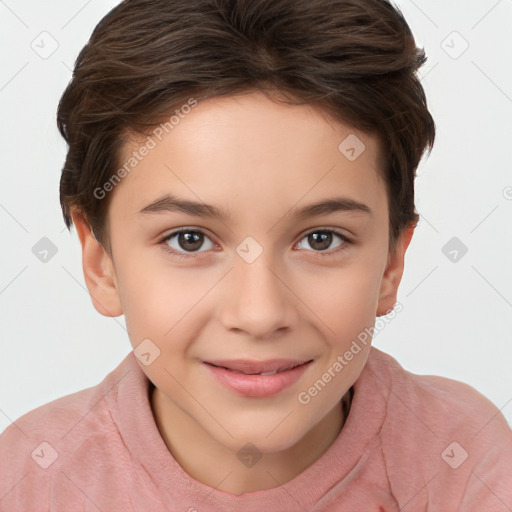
[150,387,353,495]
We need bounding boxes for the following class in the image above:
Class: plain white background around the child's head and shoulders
[0,0,512,431]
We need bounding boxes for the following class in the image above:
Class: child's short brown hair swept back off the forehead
[57,0,435,252]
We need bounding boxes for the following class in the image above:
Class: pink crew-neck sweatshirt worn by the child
[0,348,512,512]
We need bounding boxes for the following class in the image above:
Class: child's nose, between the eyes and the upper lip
[219,251,299,339]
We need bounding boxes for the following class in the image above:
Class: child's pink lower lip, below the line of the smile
[204,361,312,398]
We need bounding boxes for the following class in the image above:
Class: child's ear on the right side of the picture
[377,224,416,316]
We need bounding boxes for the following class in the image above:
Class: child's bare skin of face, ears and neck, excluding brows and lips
[73,92,414,495]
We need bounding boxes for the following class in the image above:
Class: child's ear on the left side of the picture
[72,210,123,317]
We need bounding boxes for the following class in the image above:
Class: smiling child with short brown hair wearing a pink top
[0,0,512,512]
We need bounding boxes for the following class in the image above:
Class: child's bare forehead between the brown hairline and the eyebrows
[111,92,387,223]
